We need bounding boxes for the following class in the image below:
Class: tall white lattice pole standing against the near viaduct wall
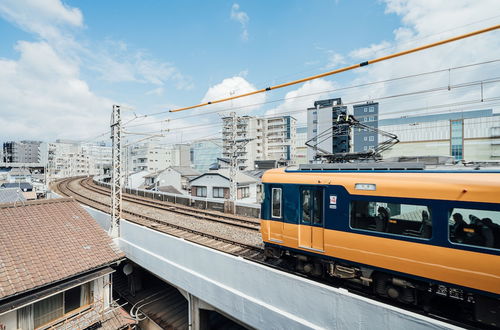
[109,105,122,238]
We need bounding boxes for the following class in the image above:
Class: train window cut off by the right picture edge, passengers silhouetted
[448,208,500,249]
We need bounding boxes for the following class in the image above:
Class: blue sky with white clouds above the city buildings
[0,0,500,142]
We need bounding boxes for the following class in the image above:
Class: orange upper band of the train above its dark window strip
[262,168,500,203]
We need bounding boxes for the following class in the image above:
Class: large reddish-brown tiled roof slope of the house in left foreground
[0,198,124,301]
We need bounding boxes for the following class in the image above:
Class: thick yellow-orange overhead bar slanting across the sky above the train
[169,24,500,112]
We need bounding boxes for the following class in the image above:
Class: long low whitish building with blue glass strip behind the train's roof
[379,109,500,161]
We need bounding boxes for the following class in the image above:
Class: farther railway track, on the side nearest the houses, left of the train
[81,178,260,231]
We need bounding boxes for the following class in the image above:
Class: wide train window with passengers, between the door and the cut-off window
[350,201,432,238]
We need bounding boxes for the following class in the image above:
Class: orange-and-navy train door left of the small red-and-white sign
[299,186,325,251]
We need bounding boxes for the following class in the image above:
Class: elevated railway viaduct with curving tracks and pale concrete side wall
[53,177,459,329]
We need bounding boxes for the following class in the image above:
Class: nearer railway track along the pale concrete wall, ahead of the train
[55,178,264,260]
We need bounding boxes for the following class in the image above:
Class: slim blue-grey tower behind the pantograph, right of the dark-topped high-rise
[353,102,378,152]
